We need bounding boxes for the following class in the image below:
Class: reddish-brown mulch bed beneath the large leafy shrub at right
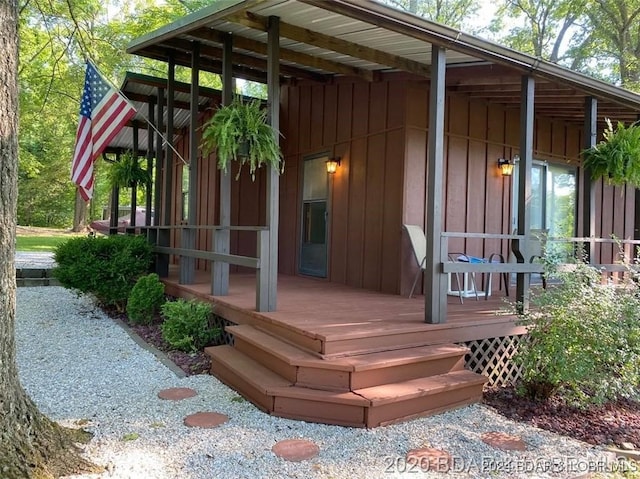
[484,388,640,449]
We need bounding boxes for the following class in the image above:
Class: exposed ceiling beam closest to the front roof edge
[227,12,431,77]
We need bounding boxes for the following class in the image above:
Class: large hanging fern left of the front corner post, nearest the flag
[201,97,284,180]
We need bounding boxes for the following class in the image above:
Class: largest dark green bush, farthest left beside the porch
[53,235,152,312]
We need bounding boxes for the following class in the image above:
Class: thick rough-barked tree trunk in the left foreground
[0,0,97,479]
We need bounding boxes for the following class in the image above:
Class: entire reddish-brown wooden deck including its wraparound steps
[165,269,523,428]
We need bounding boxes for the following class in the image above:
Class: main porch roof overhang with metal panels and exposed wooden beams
[127,0,640,128]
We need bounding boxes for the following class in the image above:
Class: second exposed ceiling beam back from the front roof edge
[189,28,374,81]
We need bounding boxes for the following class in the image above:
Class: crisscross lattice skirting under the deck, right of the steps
[463,336,523,386]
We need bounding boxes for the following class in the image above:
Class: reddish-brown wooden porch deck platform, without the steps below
[165,269,524,357]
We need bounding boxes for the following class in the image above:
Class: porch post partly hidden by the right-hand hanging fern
[581,96,598,263]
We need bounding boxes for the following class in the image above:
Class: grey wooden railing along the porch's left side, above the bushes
[142,225,269,311]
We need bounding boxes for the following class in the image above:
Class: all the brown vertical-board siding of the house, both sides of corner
[161,75,634,294]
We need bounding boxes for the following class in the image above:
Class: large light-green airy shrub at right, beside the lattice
[515,263,640,408]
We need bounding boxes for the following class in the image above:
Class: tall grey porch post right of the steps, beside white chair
[424,45,447,324]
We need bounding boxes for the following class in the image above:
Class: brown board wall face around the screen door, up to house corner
[280,77,405,293]
